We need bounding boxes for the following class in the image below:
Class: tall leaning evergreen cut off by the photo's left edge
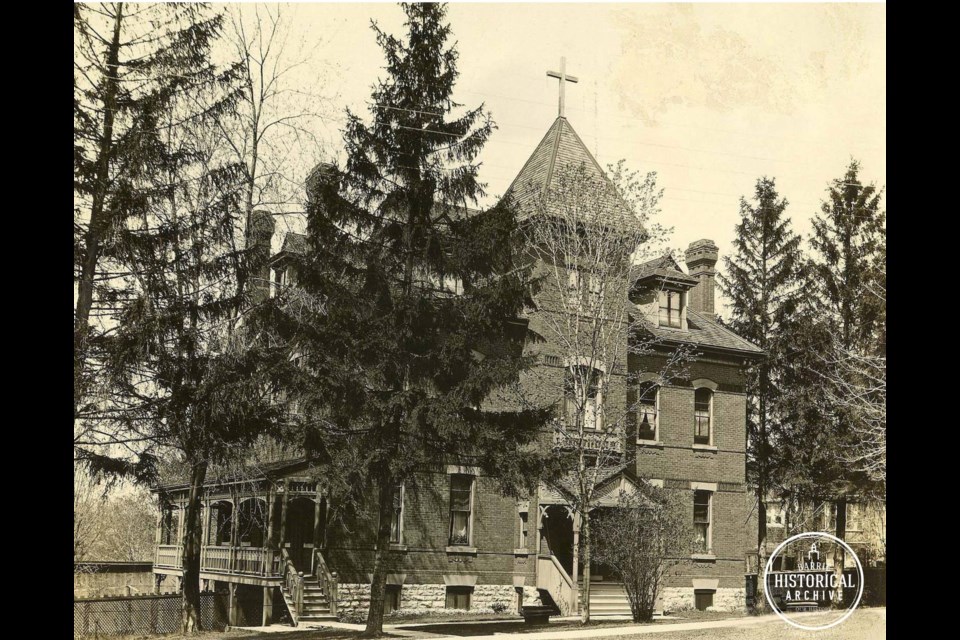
[73,2,244,424]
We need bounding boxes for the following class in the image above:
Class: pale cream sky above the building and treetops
[240,3,886,316]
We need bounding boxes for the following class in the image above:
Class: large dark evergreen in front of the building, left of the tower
[285,4,548,635]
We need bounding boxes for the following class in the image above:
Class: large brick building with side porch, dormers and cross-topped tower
[154,117,761,623]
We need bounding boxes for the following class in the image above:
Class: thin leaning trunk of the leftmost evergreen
[73,3,123,419]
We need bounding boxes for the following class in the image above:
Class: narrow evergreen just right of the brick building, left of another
[719,177,803,606]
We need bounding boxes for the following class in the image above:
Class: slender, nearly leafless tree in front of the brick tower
[524,161,690,622]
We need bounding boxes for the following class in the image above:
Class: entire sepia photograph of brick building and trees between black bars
[73,1,887,640]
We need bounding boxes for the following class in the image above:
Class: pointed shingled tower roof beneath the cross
[504,116,633,228]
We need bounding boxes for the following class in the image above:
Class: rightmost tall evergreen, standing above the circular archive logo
[785,160,886,596]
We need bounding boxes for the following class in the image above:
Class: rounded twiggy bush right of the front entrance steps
[594,481,693,622]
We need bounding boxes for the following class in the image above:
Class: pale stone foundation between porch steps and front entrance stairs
[337,583,542,619]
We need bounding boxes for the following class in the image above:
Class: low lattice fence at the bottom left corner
[73,591,227,638]
